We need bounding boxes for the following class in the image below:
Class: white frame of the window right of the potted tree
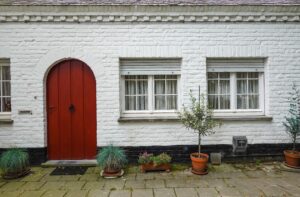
[207,72,265,116]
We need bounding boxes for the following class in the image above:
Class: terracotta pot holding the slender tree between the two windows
[190,153,209,175]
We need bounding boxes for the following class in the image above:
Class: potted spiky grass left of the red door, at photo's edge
[0,148,30,179]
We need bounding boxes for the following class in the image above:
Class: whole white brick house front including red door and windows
[0,0,300,162]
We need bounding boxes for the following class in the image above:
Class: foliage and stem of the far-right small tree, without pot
[283,84,300,151]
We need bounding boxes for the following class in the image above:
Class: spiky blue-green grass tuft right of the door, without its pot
[97,145,127,170]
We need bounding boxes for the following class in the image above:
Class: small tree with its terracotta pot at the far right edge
[283,84,300,168]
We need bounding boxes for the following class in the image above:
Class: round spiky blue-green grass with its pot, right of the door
[97,145,127,177]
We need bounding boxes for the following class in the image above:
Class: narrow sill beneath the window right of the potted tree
[213,115,273,121]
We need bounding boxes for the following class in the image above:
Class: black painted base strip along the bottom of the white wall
[0,144,300,165]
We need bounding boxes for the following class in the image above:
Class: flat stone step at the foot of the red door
[41,159,97,167]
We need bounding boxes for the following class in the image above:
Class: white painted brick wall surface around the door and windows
[0,23,300,148]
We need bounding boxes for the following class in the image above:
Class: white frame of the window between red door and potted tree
[120,74,181,118]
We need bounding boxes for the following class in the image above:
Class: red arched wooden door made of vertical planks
[47,60,96,160]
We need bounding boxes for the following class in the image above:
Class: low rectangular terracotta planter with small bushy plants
[138,152,172,172]
